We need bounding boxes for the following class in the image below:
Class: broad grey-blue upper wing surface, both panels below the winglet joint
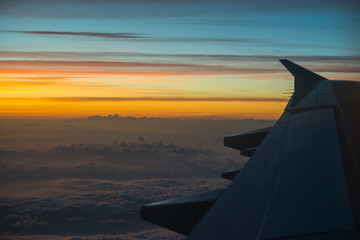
[188,108,354,239]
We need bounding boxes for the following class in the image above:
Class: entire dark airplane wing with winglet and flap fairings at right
[140,60,360,240]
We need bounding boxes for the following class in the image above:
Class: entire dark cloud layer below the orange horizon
[0,115,273,237]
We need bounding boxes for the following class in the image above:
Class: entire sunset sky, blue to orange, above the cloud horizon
[0,0,360,119]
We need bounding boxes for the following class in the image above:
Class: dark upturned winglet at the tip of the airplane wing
[279,59,328,106]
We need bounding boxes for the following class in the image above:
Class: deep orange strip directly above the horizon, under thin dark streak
[0,100,286,119]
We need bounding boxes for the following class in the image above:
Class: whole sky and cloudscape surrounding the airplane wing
[0,0,360,240]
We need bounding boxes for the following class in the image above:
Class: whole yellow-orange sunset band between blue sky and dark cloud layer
[0,57,357,119]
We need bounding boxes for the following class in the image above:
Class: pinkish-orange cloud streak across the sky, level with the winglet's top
[0,60,360,75]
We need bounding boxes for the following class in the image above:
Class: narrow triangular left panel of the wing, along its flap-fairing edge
[188,113,290,239]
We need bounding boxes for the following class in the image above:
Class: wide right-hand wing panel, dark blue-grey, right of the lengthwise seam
[262,108,354,239]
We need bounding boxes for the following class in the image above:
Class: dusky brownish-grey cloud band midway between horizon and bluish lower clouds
[0,142,245,181]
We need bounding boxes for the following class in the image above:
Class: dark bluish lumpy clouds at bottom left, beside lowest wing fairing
[0,179,227,235]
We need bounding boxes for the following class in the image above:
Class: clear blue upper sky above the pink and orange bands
[0,0,360,56]
